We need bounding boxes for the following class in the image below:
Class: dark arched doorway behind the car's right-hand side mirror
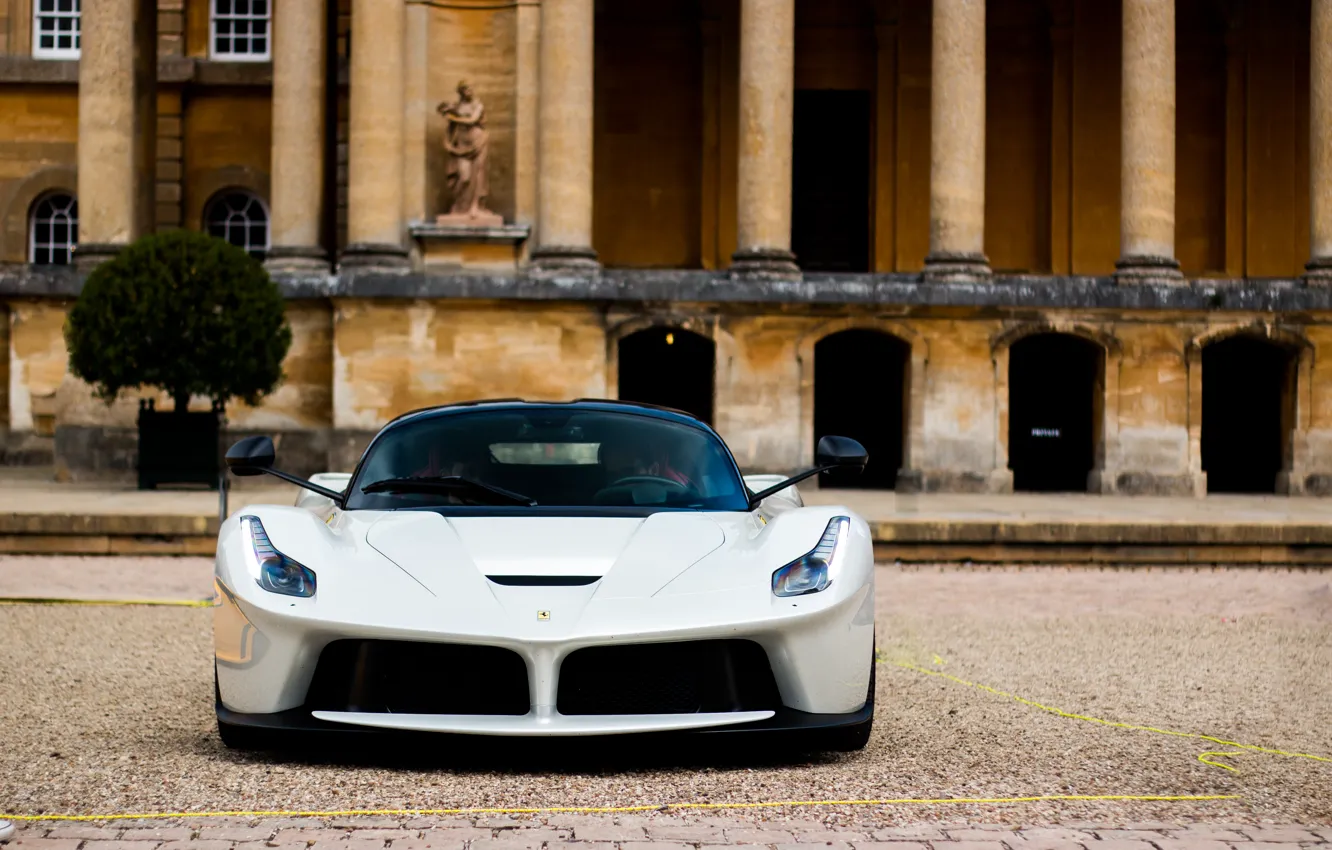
[814,330,911,490]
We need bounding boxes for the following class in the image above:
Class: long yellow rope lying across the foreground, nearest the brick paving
[0,794,1240,821]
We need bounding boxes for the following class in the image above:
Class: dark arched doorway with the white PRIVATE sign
[1008,333,1106,493]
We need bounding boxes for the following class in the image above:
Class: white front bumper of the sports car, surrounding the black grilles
[214,572,874,735]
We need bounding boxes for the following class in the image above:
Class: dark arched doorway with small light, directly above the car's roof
[619,328,717,425]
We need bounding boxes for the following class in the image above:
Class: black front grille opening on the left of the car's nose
[305,639,531,714]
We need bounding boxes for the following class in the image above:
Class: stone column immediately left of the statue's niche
[342,0,406,266]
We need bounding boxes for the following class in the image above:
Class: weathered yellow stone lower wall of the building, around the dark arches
[10,270,1332,494]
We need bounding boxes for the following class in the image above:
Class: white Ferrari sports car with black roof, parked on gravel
[213,401,874,750]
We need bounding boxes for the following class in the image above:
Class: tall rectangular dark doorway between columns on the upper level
[791,89,872,272]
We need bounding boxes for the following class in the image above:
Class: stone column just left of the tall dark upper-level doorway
[731,0,793,277]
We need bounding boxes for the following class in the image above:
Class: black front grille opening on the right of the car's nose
[555,639,781,714]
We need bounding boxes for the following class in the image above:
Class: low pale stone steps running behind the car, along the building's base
[0,469,1332,568]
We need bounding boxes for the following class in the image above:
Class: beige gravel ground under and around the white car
[0,558,1332,825]
